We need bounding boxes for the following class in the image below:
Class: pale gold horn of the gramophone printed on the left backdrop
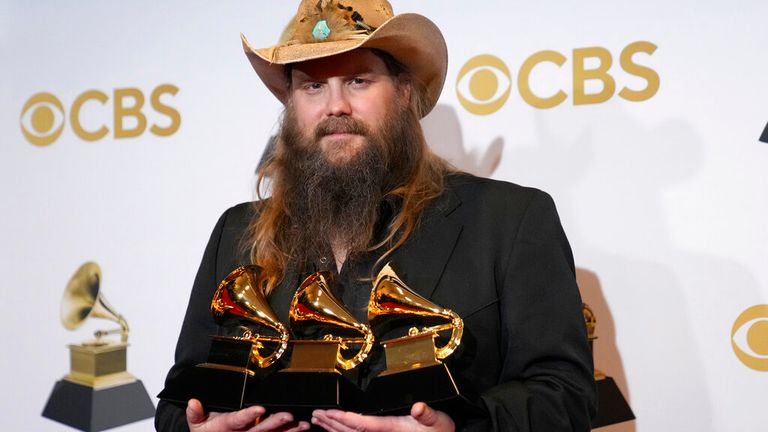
[61,262,128,342]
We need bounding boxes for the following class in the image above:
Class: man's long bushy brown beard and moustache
[273,107,421,265]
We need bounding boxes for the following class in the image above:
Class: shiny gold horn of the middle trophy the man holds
[289,272,373,370]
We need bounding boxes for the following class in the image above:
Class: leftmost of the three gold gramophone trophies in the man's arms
[158,265,289,411]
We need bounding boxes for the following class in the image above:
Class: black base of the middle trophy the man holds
[249,371,363,420]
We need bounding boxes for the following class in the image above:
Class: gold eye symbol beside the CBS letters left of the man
[19,93,64,147]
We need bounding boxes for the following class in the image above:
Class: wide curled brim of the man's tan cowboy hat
[240,13,448,116]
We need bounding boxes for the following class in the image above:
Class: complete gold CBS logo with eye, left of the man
[20,84,181,147]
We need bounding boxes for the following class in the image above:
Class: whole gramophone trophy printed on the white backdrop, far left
[43,262,155,431]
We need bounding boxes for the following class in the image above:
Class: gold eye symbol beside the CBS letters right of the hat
[456,54,512,115]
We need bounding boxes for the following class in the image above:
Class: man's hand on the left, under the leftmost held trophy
[187,399,309,432]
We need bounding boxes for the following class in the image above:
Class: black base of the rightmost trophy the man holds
[361,363,470,415]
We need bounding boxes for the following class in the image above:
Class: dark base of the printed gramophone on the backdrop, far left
[43,380,155,432]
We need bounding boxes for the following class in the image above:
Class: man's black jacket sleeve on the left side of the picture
[155,210,230,432]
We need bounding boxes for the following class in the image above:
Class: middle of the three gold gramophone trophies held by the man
[255,272,373,418]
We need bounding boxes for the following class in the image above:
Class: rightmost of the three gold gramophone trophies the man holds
[366,264,464,413]
